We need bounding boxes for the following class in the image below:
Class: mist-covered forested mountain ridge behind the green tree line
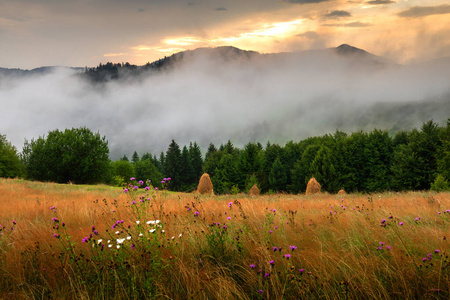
[0,45,450,159]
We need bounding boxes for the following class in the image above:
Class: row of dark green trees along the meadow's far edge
[0,119,450,194]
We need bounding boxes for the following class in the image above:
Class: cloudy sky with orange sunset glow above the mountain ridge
[0,0,450,69]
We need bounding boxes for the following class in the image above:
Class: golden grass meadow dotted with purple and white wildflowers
[0,179,450,299]
